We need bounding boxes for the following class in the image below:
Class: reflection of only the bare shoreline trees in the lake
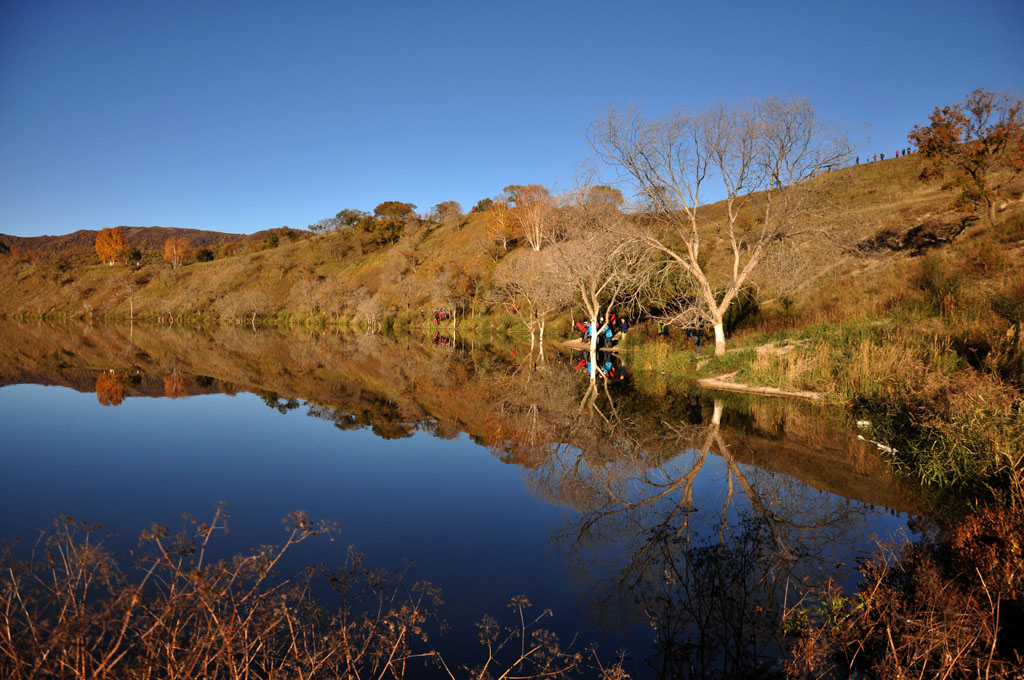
[507,364,863,678]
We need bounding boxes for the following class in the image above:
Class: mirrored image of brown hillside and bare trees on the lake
[0,325,924,677]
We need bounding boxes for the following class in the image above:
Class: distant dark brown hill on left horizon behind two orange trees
[0,226,254,259]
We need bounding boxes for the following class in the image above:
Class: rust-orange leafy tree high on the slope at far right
[907,89,1024,224]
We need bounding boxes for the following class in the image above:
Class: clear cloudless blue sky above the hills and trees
[0,0,1024,236]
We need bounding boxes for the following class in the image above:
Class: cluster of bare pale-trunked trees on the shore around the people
[486,98,851,354]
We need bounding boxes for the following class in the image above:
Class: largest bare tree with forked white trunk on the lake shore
[589,98,850,355]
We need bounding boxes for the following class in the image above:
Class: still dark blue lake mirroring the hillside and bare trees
[0,324,927,677]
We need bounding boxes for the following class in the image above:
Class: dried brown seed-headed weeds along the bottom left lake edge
[0,508,625,680]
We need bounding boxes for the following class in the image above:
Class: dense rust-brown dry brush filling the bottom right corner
[787,509,1024,679]
